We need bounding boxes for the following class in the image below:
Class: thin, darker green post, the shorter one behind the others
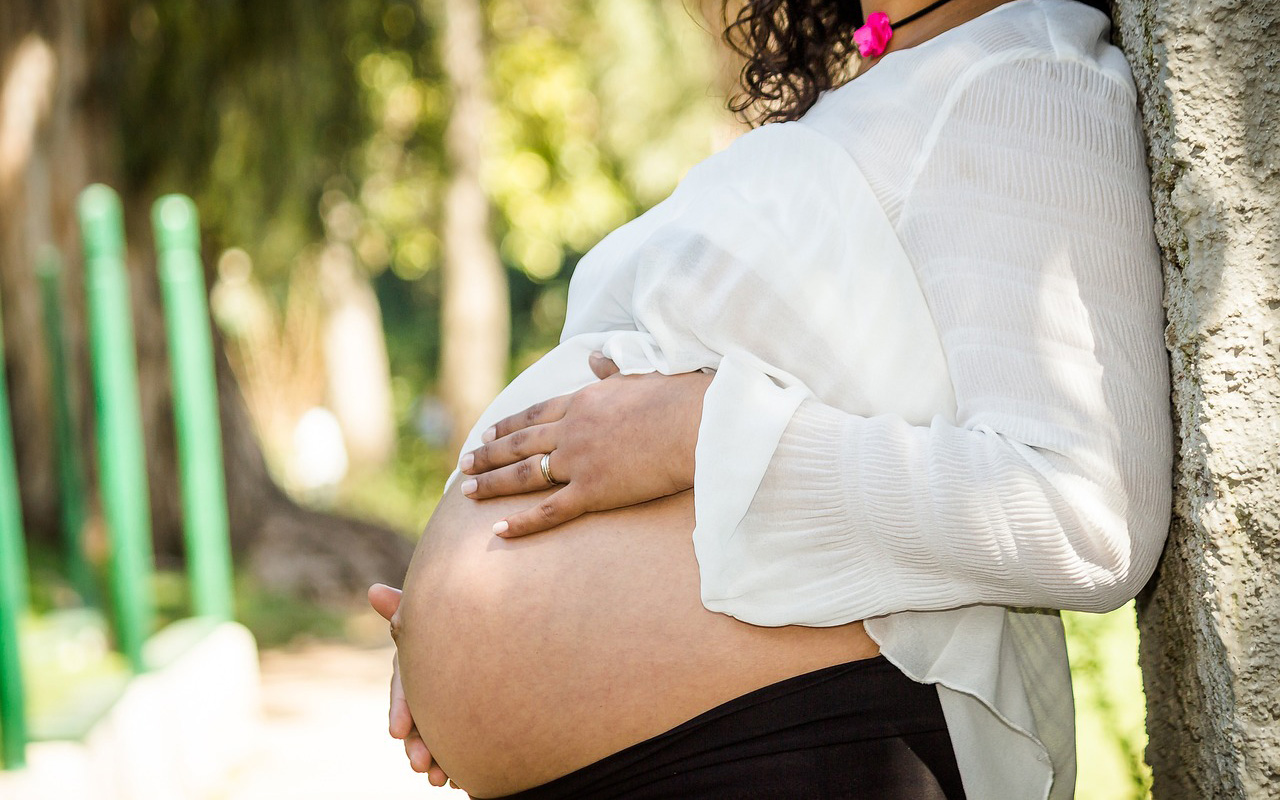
[36,247,97,603]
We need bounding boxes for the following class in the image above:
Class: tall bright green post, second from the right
[77,184,155,672]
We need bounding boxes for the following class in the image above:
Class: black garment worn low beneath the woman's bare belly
[483,657,964,800]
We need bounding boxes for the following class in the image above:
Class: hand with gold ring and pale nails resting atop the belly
[460,353,712,538]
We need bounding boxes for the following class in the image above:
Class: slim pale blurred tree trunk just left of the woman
[424,0,511,451]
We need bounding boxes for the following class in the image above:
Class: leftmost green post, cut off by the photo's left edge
[0,291,28,769]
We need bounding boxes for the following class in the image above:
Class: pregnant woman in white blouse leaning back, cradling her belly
[370,0,1170,800]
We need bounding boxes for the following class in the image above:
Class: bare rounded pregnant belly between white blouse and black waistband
[397,489,877,797]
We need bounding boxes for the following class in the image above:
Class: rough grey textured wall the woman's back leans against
[1116,0,1280,800]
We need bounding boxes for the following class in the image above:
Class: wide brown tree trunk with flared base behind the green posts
[0,0,412,602]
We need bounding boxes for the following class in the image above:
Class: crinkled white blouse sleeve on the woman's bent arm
[686,58,1171,625]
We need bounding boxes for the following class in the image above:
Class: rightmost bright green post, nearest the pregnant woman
[151,195,233,620]
